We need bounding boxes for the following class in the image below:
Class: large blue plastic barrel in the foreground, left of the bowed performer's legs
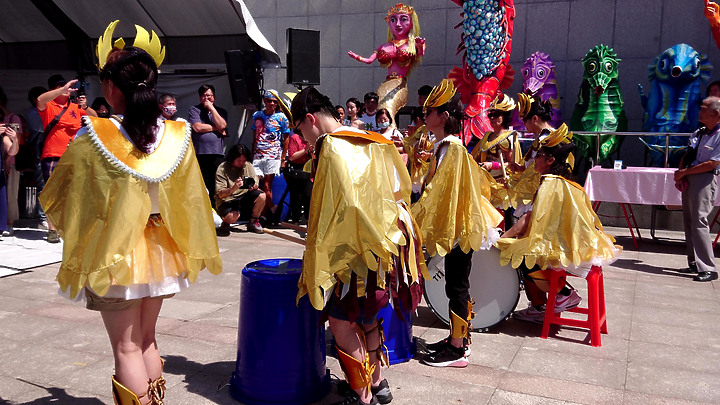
[230,259,330,405]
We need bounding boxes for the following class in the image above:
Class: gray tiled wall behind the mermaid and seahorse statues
[245,0,720,131]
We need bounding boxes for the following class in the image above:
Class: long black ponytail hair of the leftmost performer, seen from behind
[100,46,162,153]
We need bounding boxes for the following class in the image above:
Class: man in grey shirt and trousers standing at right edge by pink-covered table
[675,97,720,281]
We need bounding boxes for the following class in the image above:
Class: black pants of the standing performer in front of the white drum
[445,246,473,319]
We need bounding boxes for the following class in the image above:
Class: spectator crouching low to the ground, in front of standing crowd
[215,143,266,236]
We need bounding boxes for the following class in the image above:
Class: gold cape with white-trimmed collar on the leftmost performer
[40,117,222,298]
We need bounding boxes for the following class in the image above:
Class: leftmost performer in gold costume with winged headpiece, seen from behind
[40,21,222,405]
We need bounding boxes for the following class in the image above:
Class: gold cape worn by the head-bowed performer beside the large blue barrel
[297,131,427,310]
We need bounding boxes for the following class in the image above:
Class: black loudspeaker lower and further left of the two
[225,50,262,105]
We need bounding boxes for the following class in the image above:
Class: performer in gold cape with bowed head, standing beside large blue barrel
[290,87,427,404]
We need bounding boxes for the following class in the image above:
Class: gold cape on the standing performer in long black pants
[412,136,503,256]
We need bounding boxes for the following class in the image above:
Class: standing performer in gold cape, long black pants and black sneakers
[412,79,502,367]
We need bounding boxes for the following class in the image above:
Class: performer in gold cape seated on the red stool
[497,140,621,323]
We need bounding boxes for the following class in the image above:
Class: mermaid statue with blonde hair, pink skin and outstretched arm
[348,3,425,121]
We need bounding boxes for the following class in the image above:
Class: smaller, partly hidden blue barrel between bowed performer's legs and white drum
[377,304,417,364]
